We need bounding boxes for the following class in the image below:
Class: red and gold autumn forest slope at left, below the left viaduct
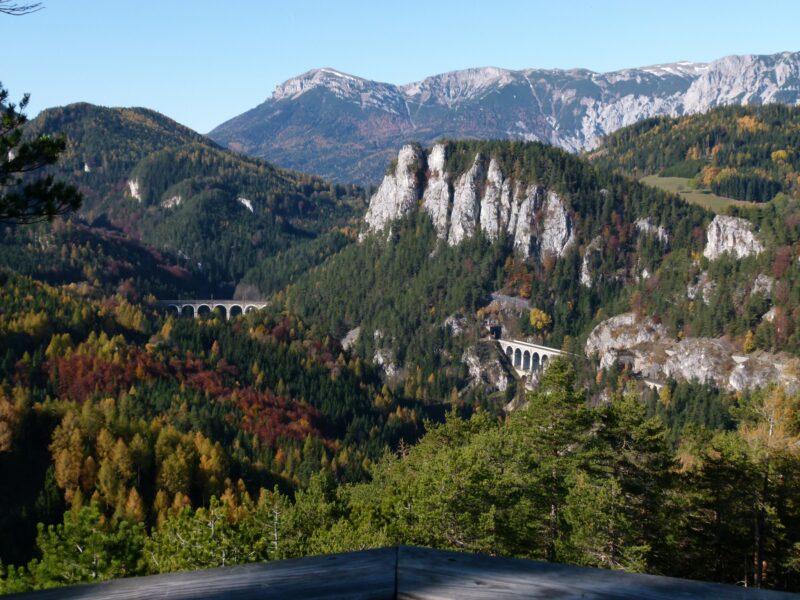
[0,269,441,576]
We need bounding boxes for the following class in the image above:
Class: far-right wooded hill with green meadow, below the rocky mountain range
[590,105,800,202]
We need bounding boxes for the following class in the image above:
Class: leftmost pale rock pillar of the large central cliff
[364,144,423,231]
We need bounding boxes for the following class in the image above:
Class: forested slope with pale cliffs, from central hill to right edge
[277,142,800,397]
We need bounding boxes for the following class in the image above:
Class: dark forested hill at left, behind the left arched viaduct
[21,104,364,295]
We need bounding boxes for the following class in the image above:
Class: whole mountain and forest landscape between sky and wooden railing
[0,41,800,593]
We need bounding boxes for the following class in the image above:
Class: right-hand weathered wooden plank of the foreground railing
[397,546,798,600]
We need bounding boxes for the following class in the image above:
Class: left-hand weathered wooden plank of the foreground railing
[6,548,397,600]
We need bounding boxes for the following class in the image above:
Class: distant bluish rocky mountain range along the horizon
[208,52,800,184]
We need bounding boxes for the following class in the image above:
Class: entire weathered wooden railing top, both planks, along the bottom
[7,546,799,600]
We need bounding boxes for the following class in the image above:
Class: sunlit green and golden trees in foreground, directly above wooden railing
[0,342,800,591]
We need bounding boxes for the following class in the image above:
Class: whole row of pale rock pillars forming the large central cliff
[362,144,575,259]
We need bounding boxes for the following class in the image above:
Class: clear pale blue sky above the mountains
[0,0,800,133]
